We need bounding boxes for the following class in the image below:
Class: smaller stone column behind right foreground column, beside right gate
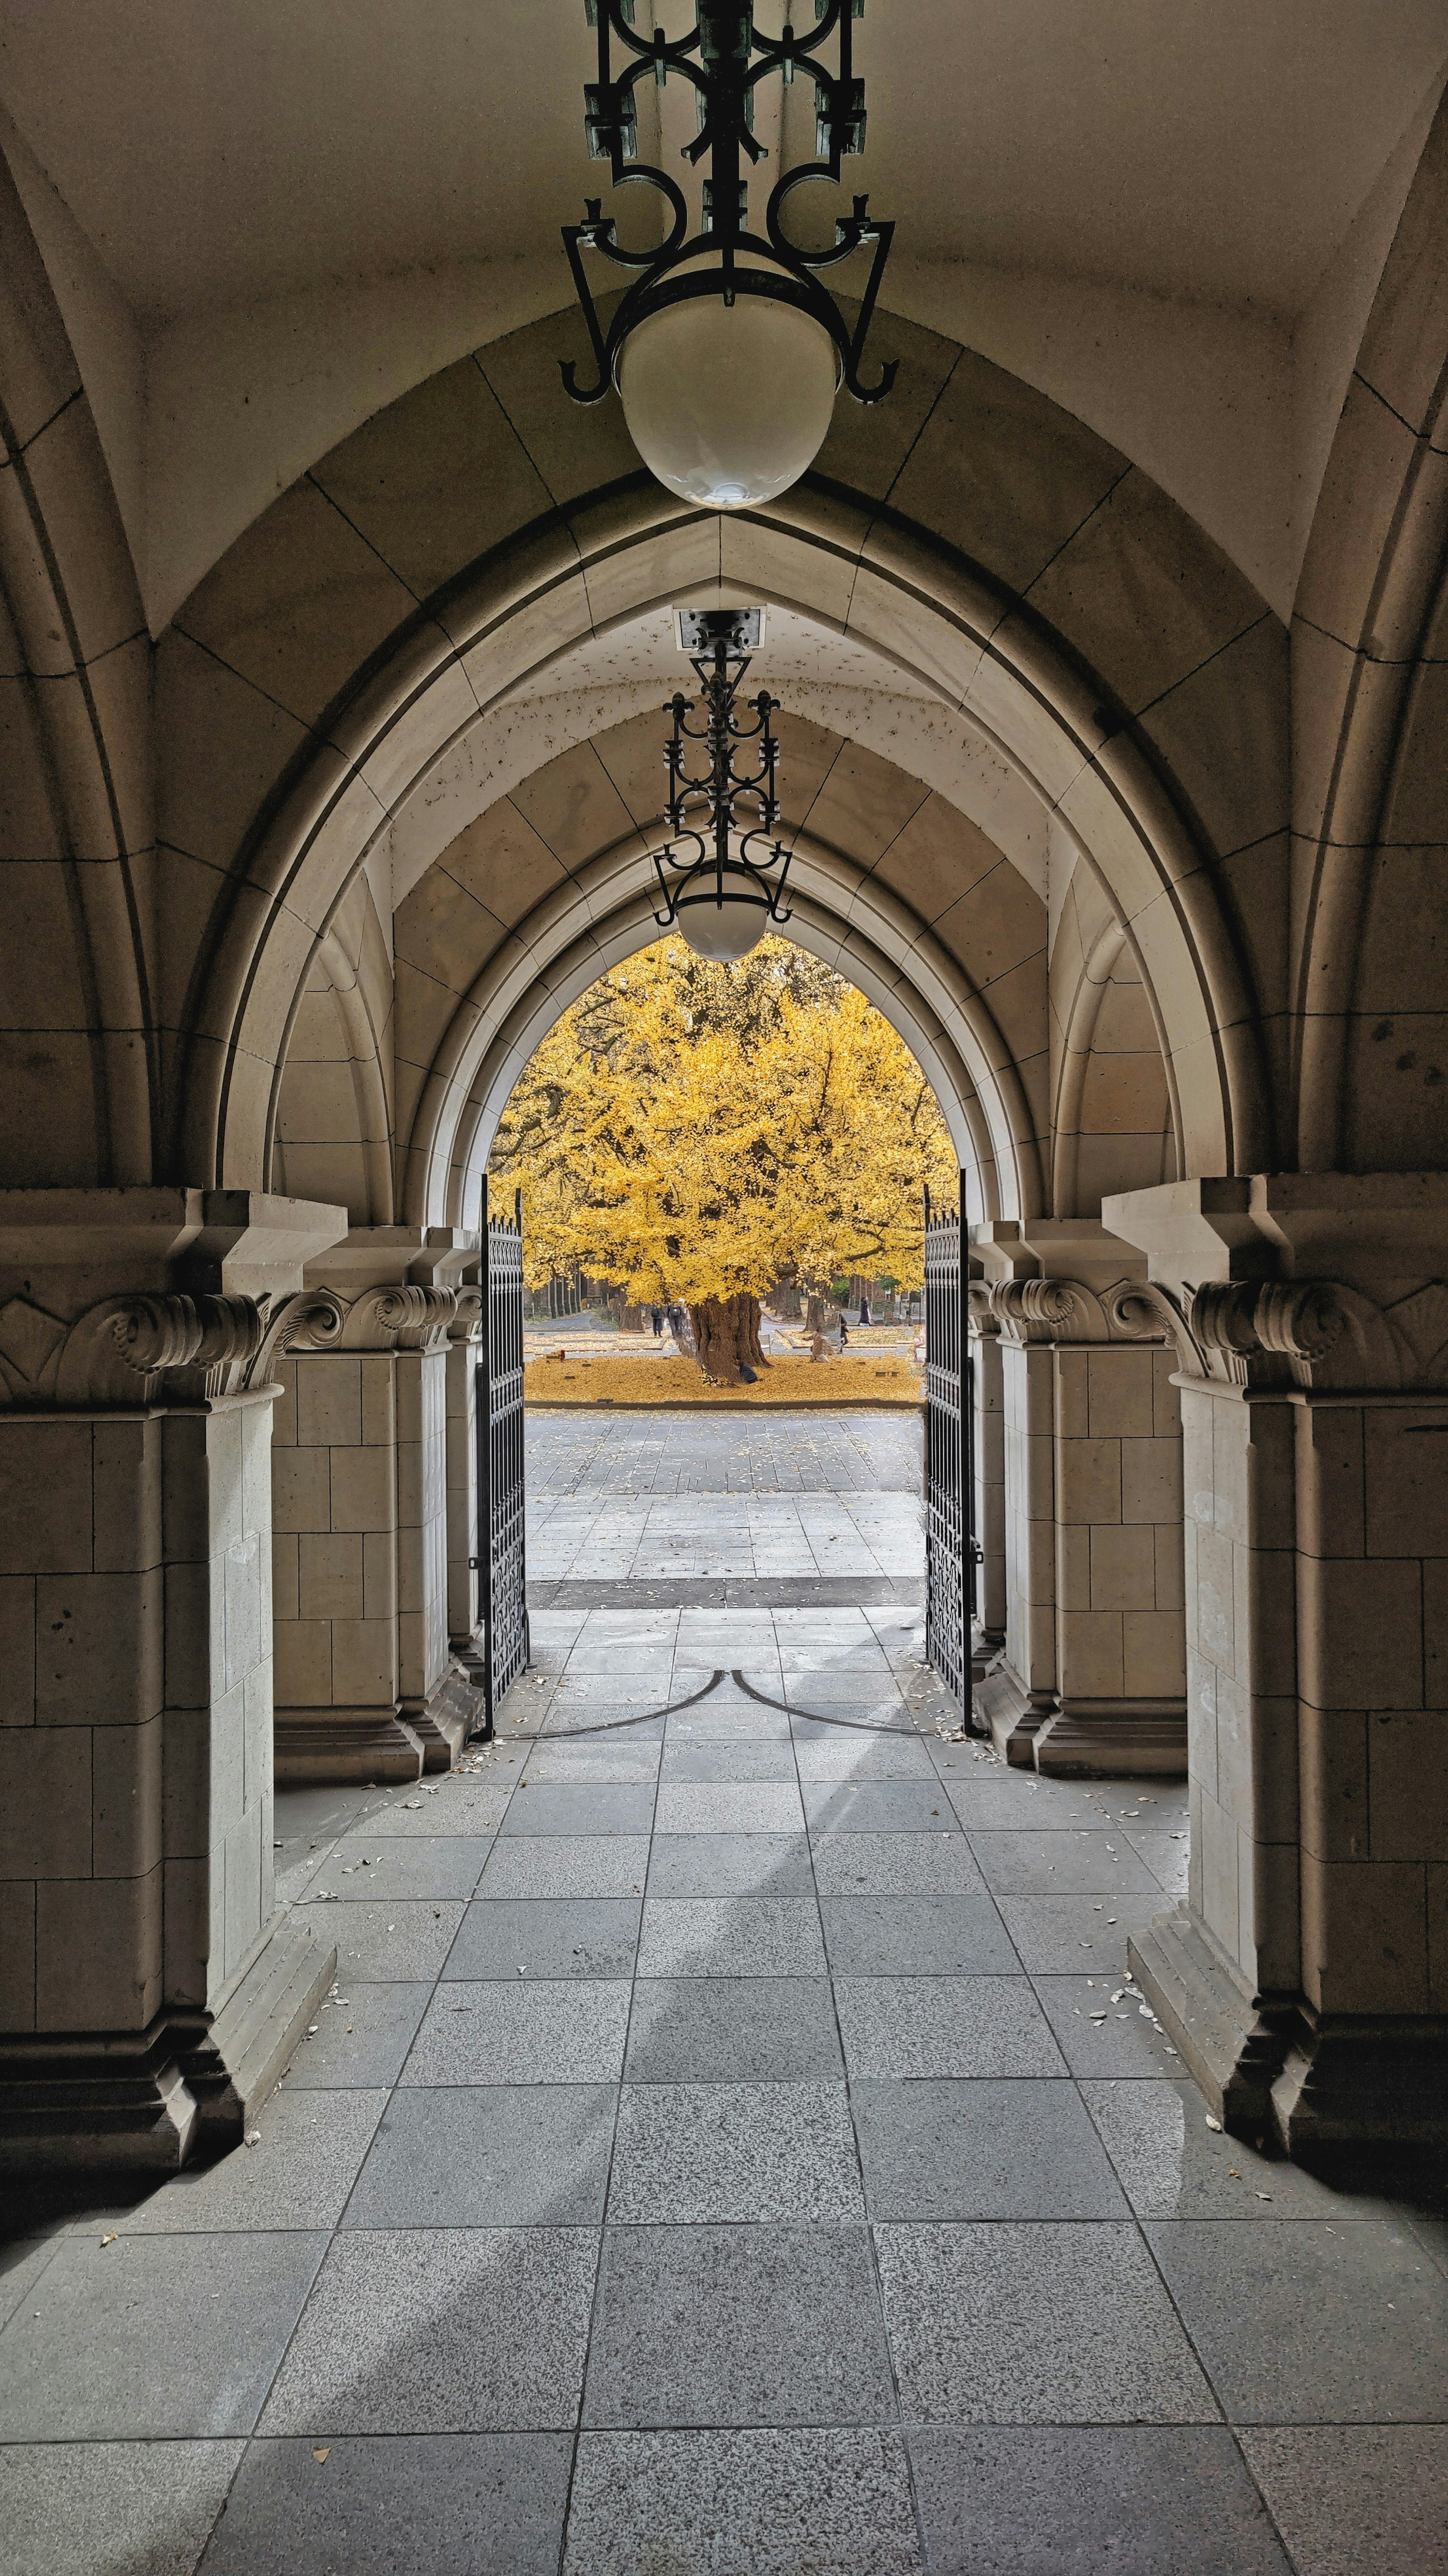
[974,1218,1185,1775]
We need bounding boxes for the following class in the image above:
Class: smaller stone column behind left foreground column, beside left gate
[276,1226,479,1780]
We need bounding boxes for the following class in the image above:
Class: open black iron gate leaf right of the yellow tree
[925,1172,977,1715]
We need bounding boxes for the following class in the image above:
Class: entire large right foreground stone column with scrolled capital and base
[1108,1172,1448,2151]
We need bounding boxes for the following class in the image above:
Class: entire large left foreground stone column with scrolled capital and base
[0,1188,345,2172]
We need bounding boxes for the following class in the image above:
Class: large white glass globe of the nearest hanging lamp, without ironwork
[618,296,840,510]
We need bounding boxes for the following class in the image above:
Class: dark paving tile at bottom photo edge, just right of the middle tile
[910,2424,1291,2576]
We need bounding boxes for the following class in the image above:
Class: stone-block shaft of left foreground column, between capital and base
[0,1396,273,2033]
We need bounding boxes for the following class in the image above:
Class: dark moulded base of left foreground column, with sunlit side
[0,1916,337,2185]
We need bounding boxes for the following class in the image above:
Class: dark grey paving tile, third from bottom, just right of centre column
[850,2076,1131,2218]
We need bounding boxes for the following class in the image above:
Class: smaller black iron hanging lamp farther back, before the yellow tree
[655,608,788,958]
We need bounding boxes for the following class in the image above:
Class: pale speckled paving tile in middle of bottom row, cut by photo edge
[564,2429,920,2576]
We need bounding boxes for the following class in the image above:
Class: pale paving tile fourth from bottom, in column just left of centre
[402,1976,629,2084]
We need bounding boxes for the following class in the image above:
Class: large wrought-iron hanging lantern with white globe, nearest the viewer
[562,0,899,510]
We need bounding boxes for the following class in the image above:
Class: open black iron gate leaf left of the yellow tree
[477,1177,528,1736]
